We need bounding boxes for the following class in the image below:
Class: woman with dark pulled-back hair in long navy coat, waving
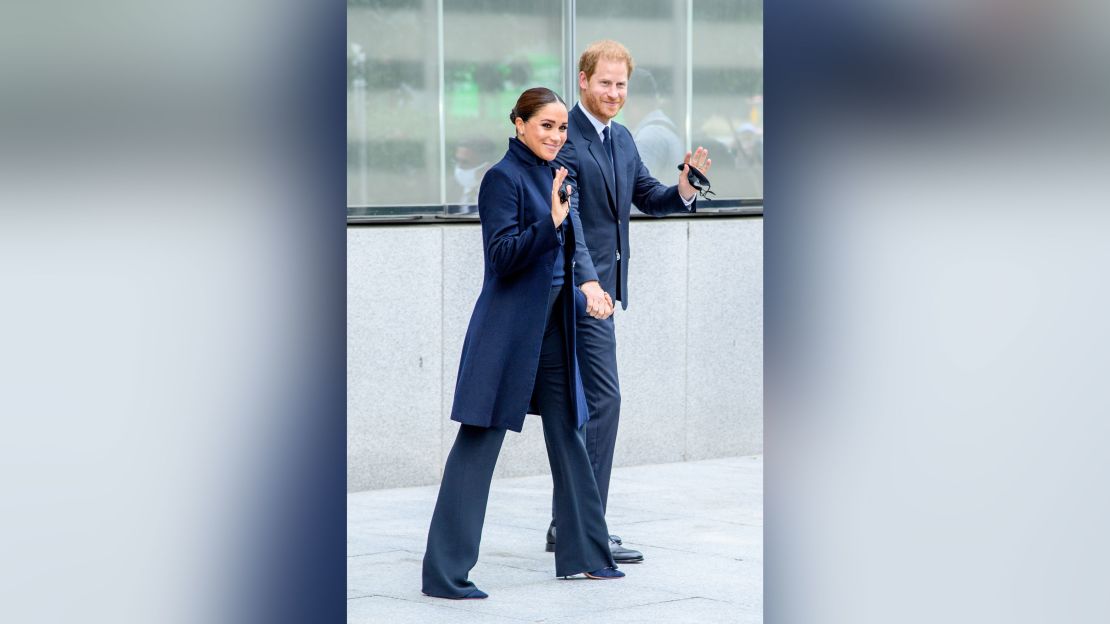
[423,88,624,598]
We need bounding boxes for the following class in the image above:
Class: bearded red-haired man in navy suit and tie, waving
[547,40,710,563]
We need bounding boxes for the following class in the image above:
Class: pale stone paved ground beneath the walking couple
[347,455,763,624]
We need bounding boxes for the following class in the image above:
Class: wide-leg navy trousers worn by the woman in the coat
[423,288,615,598]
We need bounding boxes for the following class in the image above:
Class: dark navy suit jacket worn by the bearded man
[555,104,696,309]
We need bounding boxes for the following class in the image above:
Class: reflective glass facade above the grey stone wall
[346,0,763,215]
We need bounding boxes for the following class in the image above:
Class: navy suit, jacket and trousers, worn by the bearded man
[553,103,695,515]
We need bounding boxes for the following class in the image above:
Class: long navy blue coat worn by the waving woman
[451,139,588,432]
